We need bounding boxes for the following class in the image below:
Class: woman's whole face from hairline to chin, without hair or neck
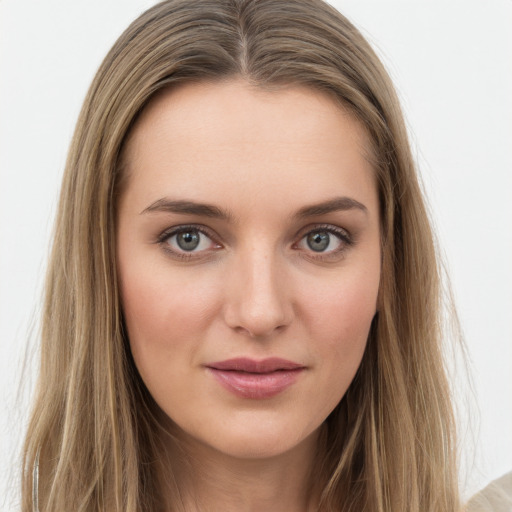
[117,81,380,458]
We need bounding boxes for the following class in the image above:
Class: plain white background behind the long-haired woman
[0,0,512,510]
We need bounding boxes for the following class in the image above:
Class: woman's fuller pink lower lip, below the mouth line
[208,368,304,399]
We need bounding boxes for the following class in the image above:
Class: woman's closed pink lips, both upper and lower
[206,357,305,399]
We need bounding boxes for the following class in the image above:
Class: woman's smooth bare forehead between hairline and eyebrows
[119,80,375,218]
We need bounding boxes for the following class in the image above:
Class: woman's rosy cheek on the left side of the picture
[120,264,219,381]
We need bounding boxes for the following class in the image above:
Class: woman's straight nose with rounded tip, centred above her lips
[224,249,293,338]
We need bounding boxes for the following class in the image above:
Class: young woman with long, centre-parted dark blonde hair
[23,0,460,512]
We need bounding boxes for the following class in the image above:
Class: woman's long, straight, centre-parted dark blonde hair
[22,0,459,512]
